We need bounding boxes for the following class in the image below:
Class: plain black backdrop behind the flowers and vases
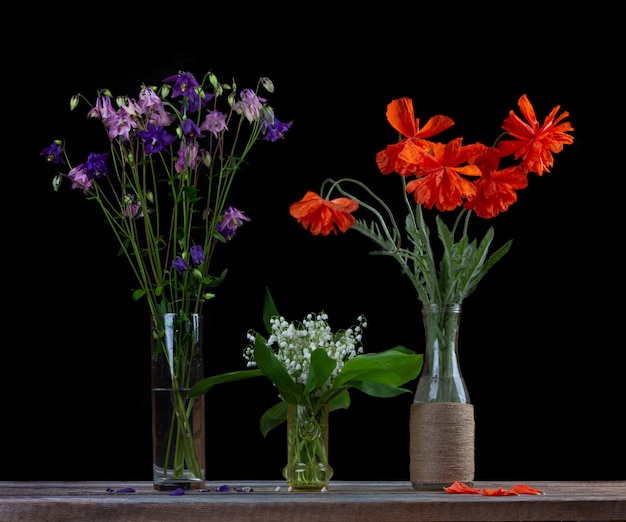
[0,1,626,481]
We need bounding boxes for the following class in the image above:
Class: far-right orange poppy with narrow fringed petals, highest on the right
[498,94,574,176]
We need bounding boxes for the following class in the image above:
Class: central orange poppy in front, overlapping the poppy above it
[398,138,484,211]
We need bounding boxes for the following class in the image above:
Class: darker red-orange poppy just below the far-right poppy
[464,147,528,219]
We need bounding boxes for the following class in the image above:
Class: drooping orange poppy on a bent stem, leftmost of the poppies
[289,191,359,236]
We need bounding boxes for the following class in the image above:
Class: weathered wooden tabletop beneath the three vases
[0,481,626,522]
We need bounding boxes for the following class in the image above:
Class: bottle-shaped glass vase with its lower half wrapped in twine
[410,304,475,491]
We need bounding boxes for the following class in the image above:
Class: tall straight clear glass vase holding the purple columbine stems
[151,313,205,490]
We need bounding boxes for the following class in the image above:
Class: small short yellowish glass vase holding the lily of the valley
[283,404,333,491]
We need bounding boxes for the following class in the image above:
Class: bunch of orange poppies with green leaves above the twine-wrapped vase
[290,95,574,305]
